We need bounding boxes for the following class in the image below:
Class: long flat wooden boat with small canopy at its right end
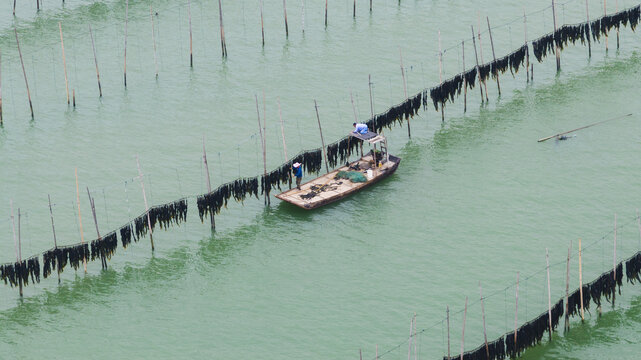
[276,132,401,210]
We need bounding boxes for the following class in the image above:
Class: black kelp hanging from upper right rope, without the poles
[423,5,641,116]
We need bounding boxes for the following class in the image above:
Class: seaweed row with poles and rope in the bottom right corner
[374,214,641,360]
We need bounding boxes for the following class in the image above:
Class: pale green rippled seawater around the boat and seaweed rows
[0,0,641,359]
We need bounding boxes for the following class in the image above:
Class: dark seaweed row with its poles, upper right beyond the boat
[425,2,641,120]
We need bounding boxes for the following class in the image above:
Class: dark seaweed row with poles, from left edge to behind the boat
[0,93,422,296]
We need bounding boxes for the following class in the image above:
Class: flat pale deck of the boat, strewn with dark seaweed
[276,153,401,209]
